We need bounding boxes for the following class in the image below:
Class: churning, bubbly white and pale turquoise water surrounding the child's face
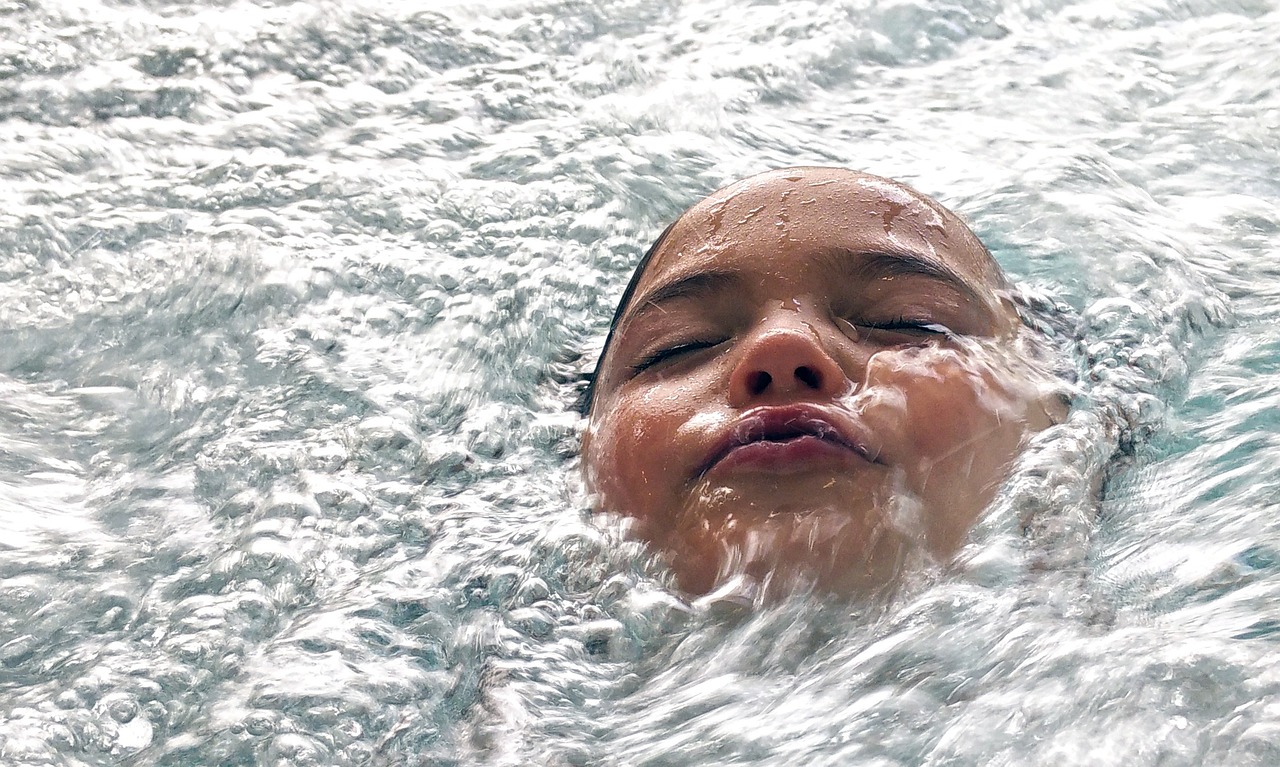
[0,0,1280,767]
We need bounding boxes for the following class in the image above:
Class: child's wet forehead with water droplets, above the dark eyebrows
[644,168,1004,291]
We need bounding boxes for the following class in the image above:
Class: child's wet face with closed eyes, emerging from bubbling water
[584,168,1050,593]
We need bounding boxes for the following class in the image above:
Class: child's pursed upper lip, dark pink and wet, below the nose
[698,405,882,476]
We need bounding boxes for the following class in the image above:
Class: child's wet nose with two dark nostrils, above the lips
[730,318,851,407]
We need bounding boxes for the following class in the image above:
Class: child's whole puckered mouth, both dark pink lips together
[699,406,881,476]
